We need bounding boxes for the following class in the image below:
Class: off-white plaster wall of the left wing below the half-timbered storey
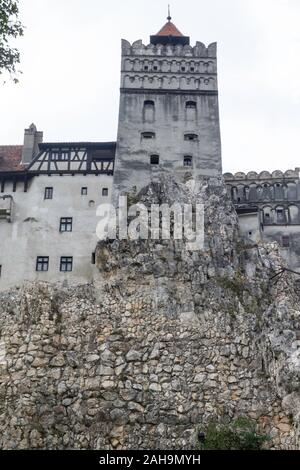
[0,175,112,290]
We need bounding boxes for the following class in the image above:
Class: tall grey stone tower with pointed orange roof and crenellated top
[114,15,222,194]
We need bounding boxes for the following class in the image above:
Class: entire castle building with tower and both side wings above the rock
[0,16,300,290]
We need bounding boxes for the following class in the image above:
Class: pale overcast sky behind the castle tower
[0,0,300,171]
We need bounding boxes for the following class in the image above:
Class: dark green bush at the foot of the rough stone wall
[199,418,268,450]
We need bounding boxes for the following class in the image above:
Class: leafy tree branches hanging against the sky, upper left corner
[0,0,24,82]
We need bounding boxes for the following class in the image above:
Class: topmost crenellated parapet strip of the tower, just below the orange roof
[122,39,217,59]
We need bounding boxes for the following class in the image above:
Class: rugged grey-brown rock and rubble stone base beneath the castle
[0,180,300,449]
